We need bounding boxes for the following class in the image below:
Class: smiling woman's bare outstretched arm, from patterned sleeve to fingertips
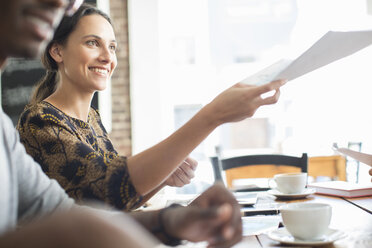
[128,81,284,194]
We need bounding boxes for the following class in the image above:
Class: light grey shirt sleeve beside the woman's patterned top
[0,110,73,221]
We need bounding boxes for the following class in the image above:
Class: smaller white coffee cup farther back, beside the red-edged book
[273,172,307,194]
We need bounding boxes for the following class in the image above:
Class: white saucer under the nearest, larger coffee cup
[268,227,345,246]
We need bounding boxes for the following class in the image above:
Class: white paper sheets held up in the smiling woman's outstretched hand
[241,30,372,85]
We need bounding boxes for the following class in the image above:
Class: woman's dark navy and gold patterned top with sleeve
[17,101,142,210]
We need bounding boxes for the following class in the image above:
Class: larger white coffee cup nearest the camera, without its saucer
[280,203,332,240]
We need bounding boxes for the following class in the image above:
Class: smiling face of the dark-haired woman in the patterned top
[58,14,117,93]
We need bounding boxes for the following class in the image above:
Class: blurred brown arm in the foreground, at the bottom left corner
[0,208,158,248]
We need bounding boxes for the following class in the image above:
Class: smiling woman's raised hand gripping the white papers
[203,80,286,126]
